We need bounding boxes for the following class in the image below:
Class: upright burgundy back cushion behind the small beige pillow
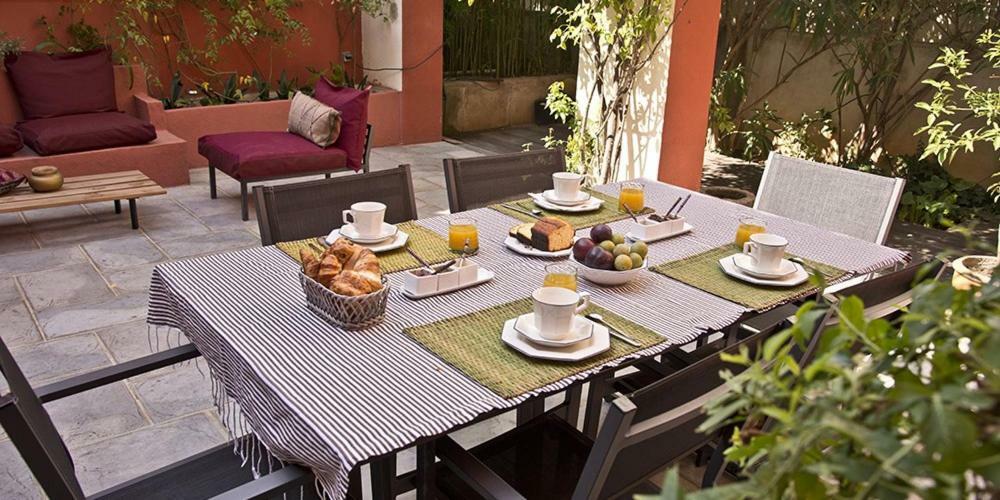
[313,78,371,172]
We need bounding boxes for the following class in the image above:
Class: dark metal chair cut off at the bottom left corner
[0,334,314,500]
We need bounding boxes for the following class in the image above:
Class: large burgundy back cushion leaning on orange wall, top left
[4,49,118,120]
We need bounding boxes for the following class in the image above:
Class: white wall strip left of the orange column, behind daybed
[361,0,403,90]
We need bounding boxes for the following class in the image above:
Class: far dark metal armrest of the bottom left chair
[35,344,201,403]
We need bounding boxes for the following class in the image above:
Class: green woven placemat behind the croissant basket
[275,221,455,273]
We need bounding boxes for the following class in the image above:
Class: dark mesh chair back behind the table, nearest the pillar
[444,149,566,213]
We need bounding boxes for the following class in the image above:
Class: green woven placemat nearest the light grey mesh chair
[651,244,845,311]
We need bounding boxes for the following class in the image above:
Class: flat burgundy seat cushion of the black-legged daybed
[198,132,347,180]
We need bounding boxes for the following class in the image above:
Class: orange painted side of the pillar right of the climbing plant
[659,0,722,190]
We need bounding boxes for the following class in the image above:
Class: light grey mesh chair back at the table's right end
[754,152,906,245]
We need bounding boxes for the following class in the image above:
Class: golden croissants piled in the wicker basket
[299,238,382,297]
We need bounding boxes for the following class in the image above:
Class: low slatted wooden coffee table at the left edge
[0,170,167,229]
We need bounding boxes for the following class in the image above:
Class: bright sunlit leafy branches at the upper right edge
[916,30,1000,202]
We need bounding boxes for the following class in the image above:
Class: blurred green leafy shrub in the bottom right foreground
[660,268,1000,499]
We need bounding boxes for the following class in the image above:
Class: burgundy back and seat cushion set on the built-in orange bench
[4,49,156,156]
